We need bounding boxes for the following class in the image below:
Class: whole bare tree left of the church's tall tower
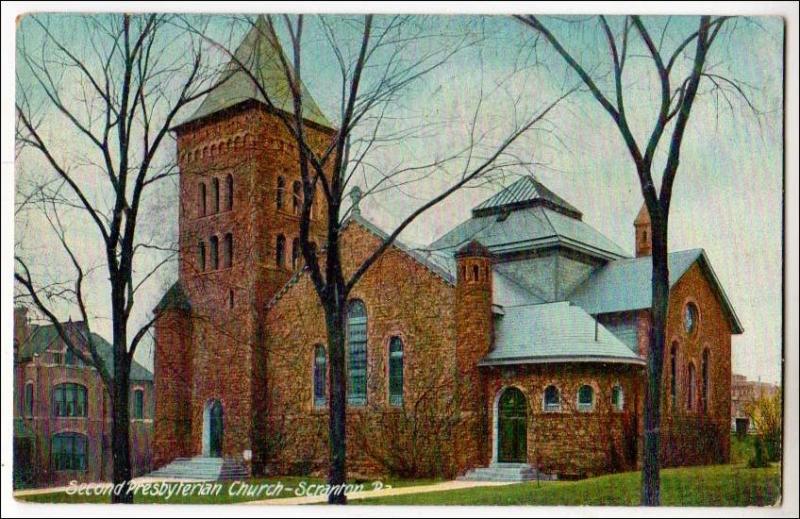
[14,14,224,503]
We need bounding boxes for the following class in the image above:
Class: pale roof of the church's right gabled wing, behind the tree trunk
[568,249,744,333]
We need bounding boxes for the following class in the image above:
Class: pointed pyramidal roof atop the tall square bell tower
[181,15,332,128]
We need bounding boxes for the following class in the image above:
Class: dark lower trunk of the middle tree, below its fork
[325,304,347,505]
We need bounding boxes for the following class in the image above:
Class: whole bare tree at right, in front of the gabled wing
[515,15,754,506]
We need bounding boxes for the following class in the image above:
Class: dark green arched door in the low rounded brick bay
[497,387,528,463]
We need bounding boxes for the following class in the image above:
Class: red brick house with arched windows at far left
[14,308,153,486]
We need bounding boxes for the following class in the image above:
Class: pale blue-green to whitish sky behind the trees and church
[15,16,783,382]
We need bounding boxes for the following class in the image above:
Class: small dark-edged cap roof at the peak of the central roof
[472,175,583,220]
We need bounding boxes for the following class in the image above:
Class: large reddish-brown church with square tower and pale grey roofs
[153,20,742,484]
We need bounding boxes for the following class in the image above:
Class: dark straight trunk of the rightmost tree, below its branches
[642,209,669,506]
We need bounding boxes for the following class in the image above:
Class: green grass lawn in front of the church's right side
[352,465,781,506]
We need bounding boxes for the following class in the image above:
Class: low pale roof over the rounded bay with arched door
[480,301,644,366]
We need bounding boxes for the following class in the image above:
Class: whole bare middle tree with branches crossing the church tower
[200,15,572,504]
